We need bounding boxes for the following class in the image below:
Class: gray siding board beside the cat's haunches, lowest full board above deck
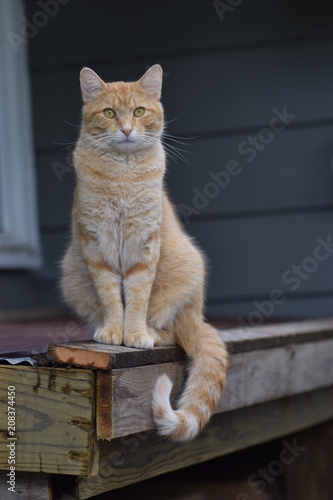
[38,210,333,303]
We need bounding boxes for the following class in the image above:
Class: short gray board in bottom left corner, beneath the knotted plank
[0,471,52,500]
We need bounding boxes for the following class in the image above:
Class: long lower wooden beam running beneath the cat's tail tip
[78,387,333,499]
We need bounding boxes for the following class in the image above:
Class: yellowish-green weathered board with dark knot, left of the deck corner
[0,366,96,474]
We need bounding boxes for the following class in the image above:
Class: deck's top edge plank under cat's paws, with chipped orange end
[48,318,333,370]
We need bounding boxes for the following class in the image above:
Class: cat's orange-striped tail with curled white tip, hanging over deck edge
[152,323,228,441]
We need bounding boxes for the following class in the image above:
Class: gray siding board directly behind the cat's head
[32,40,333,151]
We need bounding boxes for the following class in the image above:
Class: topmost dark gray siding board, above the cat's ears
[27,0,332,69]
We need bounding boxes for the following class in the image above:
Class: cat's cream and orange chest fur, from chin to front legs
[75,145,165,274]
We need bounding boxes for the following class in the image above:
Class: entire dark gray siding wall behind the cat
[0,0,333,322]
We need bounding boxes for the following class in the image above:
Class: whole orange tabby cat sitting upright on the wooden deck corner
[61,65,227,440]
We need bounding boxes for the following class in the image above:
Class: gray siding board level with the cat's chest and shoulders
[37,126,333,228]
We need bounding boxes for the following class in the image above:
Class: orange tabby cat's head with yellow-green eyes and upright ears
[80,64,163,153]
